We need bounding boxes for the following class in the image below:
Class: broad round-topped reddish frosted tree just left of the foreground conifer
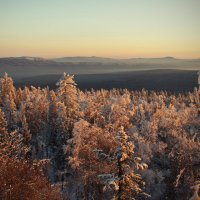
[66,119,116,199]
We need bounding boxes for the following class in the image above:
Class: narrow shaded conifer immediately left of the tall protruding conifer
[48,91,69,181]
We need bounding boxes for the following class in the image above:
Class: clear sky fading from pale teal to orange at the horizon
[0,0,200,58]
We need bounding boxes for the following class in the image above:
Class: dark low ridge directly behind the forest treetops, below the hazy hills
[14,70,197,93]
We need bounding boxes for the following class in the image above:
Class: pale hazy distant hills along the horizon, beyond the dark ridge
[0,57,200,78]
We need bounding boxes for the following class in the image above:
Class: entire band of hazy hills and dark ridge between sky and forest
[0,56,200,92]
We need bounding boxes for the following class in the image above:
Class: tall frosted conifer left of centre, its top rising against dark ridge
[56,73,79,183]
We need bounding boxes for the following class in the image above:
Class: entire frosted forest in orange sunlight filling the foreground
[0,74,200,200]
